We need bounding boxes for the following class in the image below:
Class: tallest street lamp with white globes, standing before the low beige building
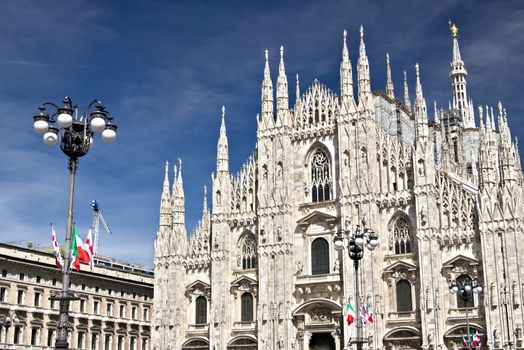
[33,97,116,349]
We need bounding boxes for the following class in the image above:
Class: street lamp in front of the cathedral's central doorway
[334,225,378,350]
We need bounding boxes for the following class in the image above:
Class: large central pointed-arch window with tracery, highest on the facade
[311,150,332,202]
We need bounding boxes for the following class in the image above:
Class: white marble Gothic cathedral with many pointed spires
[152,26,524,350]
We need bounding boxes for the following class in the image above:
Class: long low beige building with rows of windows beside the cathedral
[0,244,153,350]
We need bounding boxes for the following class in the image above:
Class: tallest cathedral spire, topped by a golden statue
[448,21,475,128]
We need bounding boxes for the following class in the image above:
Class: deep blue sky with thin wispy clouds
[0,0,524,266]
